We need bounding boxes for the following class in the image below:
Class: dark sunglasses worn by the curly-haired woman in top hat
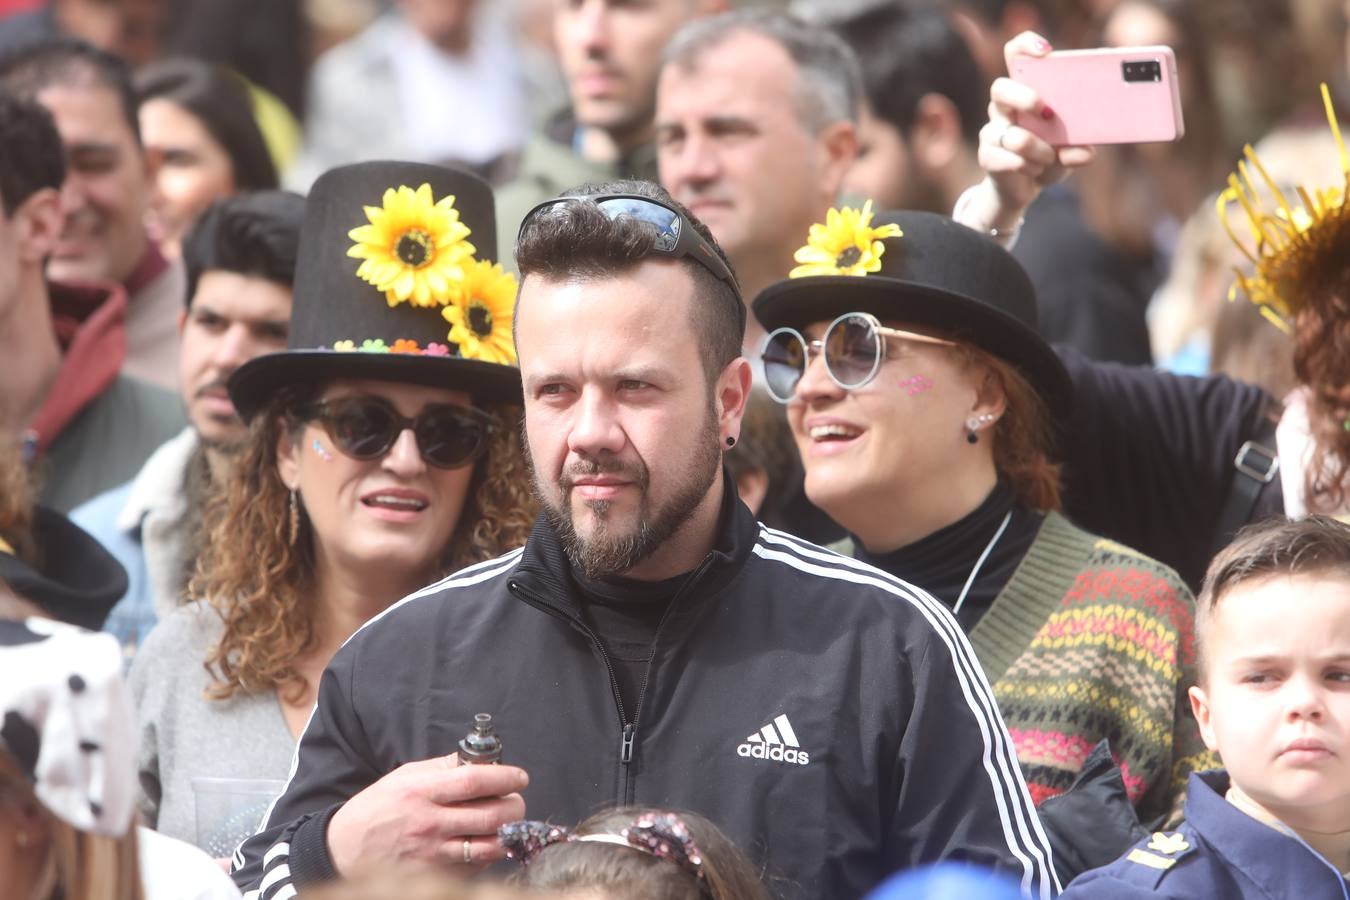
[297,397,494,468]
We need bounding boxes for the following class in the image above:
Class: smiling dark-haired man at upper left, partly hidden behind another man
[0,38,184,389]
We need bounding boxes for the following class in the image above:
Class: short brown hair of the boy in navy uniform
[1195,515,1350,683]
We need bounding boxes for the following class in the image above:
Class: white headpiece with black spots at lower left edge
[0,618,136,838]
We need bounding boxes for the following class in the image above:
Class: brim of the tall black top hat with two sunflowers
[228,349,521,422]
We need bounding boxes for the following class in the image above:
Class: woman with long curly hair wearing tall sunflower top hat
[131,163,535,857]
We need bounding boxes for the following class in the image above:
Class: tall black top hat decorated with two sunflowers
[230,162,521,420]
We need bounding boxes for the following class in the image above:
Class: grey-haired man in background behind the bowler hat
[656,9,863,356]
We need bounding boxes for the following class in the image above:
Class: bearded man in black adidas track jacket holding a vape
[235,182,1058,900]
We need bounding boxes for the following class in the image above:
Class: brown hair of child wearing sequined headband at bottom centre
[513,807,770,900]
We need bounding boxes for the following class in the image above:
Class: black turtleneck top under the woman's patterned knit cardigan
[853,479,1045,633]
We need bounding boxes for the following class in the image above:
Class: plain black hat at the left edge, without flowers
[0,506,127,631]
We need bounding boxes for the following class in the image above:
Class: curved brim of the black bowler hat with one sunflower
[753,275,1073,422]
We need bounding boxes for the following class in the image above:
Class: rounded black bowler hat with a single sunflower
[753,204,1073,420]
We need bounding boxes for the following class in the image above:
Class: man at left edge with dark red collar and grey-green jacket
[0,89,182,511]
